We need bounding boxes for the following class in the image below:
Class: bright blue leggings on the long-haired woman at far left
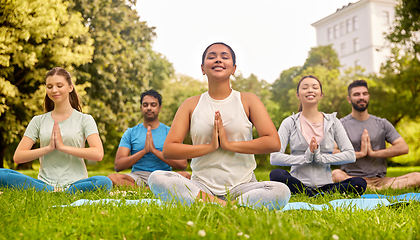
[0,168,112,193]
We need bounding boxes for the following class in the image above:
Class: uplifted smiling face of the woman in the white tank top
[201,44,236,79]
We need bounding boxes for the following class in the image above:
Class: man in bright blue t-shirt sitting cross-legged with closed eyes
[108,89,191,187]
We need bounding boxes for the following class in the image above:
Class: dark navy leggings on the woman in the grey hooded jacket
[270,169,367,197]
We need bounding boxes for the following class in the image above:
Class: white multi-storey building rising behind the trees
[312,0,397,73]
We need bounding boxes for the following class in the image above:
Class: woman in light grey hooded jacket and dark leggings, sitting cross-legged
[270,75,366,196]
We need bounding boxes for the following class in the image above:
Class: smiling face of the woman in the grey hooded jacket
[296,77,324,106]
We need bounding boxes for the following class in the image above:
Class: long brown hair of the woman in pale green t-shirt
[44,67,82,112]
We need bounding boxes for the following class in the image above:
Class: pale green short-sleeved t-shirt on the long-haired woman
[24,109,98,187]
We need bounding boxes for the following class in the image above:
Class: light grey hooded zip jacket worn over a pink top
[270,112,356,187]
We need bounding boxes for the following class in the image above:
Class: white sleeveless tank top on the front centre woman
[190,90,256,195]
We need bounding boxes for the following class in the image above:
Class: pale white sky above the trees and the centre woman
[136,0,357,83]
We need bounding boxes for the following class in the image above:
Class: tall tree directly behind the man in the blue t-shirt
[71,0,173,161]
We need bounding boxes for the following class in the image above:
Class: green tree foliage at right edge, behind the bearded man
[376,0,420,124]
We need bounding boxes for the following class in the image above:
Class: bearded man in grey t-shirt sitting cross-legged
[332,80,420,190]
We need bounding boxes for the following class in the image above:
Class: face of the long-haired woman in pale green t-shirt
[45,75,73,104]
